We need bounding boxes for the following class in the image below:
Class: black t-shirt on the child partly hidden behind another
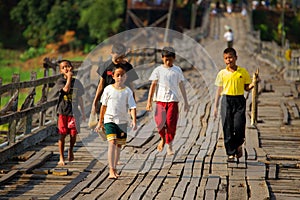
[97,60,139,87]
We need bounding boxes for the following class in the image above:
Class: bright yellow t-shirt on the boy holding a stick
[215,66,251,96]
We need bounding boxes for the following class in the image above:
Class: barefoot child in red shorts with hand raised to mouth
[56,60,85,166]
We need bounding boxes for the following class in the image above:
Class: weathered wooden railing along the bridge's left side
[0,58,91,146]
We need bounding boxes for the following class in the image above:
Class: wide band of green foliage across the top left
[10,0,125,47]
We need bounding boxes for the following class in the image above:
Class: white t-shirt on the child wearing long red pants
[149,65,184,102]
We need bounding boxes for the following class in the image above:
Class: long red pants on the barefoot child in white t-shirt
[155,102,178,144]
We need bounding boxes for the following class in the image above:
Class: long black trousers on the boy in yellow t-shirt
[221,95,246,155]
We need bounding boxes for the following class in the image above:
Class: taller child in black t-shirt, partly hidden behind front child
[91,43,139,119]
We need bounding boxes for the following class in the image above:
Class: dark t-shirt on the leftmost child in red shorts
[56,76,84,117]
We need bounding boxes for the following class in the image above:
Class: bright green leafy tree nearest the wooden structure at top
[79,0,125,42]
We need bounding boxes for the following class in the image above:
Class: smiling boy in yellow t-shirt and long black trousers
[214,48,254,162]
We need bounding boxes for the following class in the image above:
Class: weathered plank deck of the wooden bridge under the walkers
[0,3,300,200]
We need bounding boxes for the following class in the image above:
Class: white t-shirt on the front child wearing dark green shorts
[101,85,136,124]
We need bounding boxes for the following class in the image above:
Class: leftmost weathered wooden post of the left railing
[7,74,20,146]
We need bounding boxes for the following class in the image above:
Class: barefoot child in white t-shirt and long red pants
[146,47,189,155]
